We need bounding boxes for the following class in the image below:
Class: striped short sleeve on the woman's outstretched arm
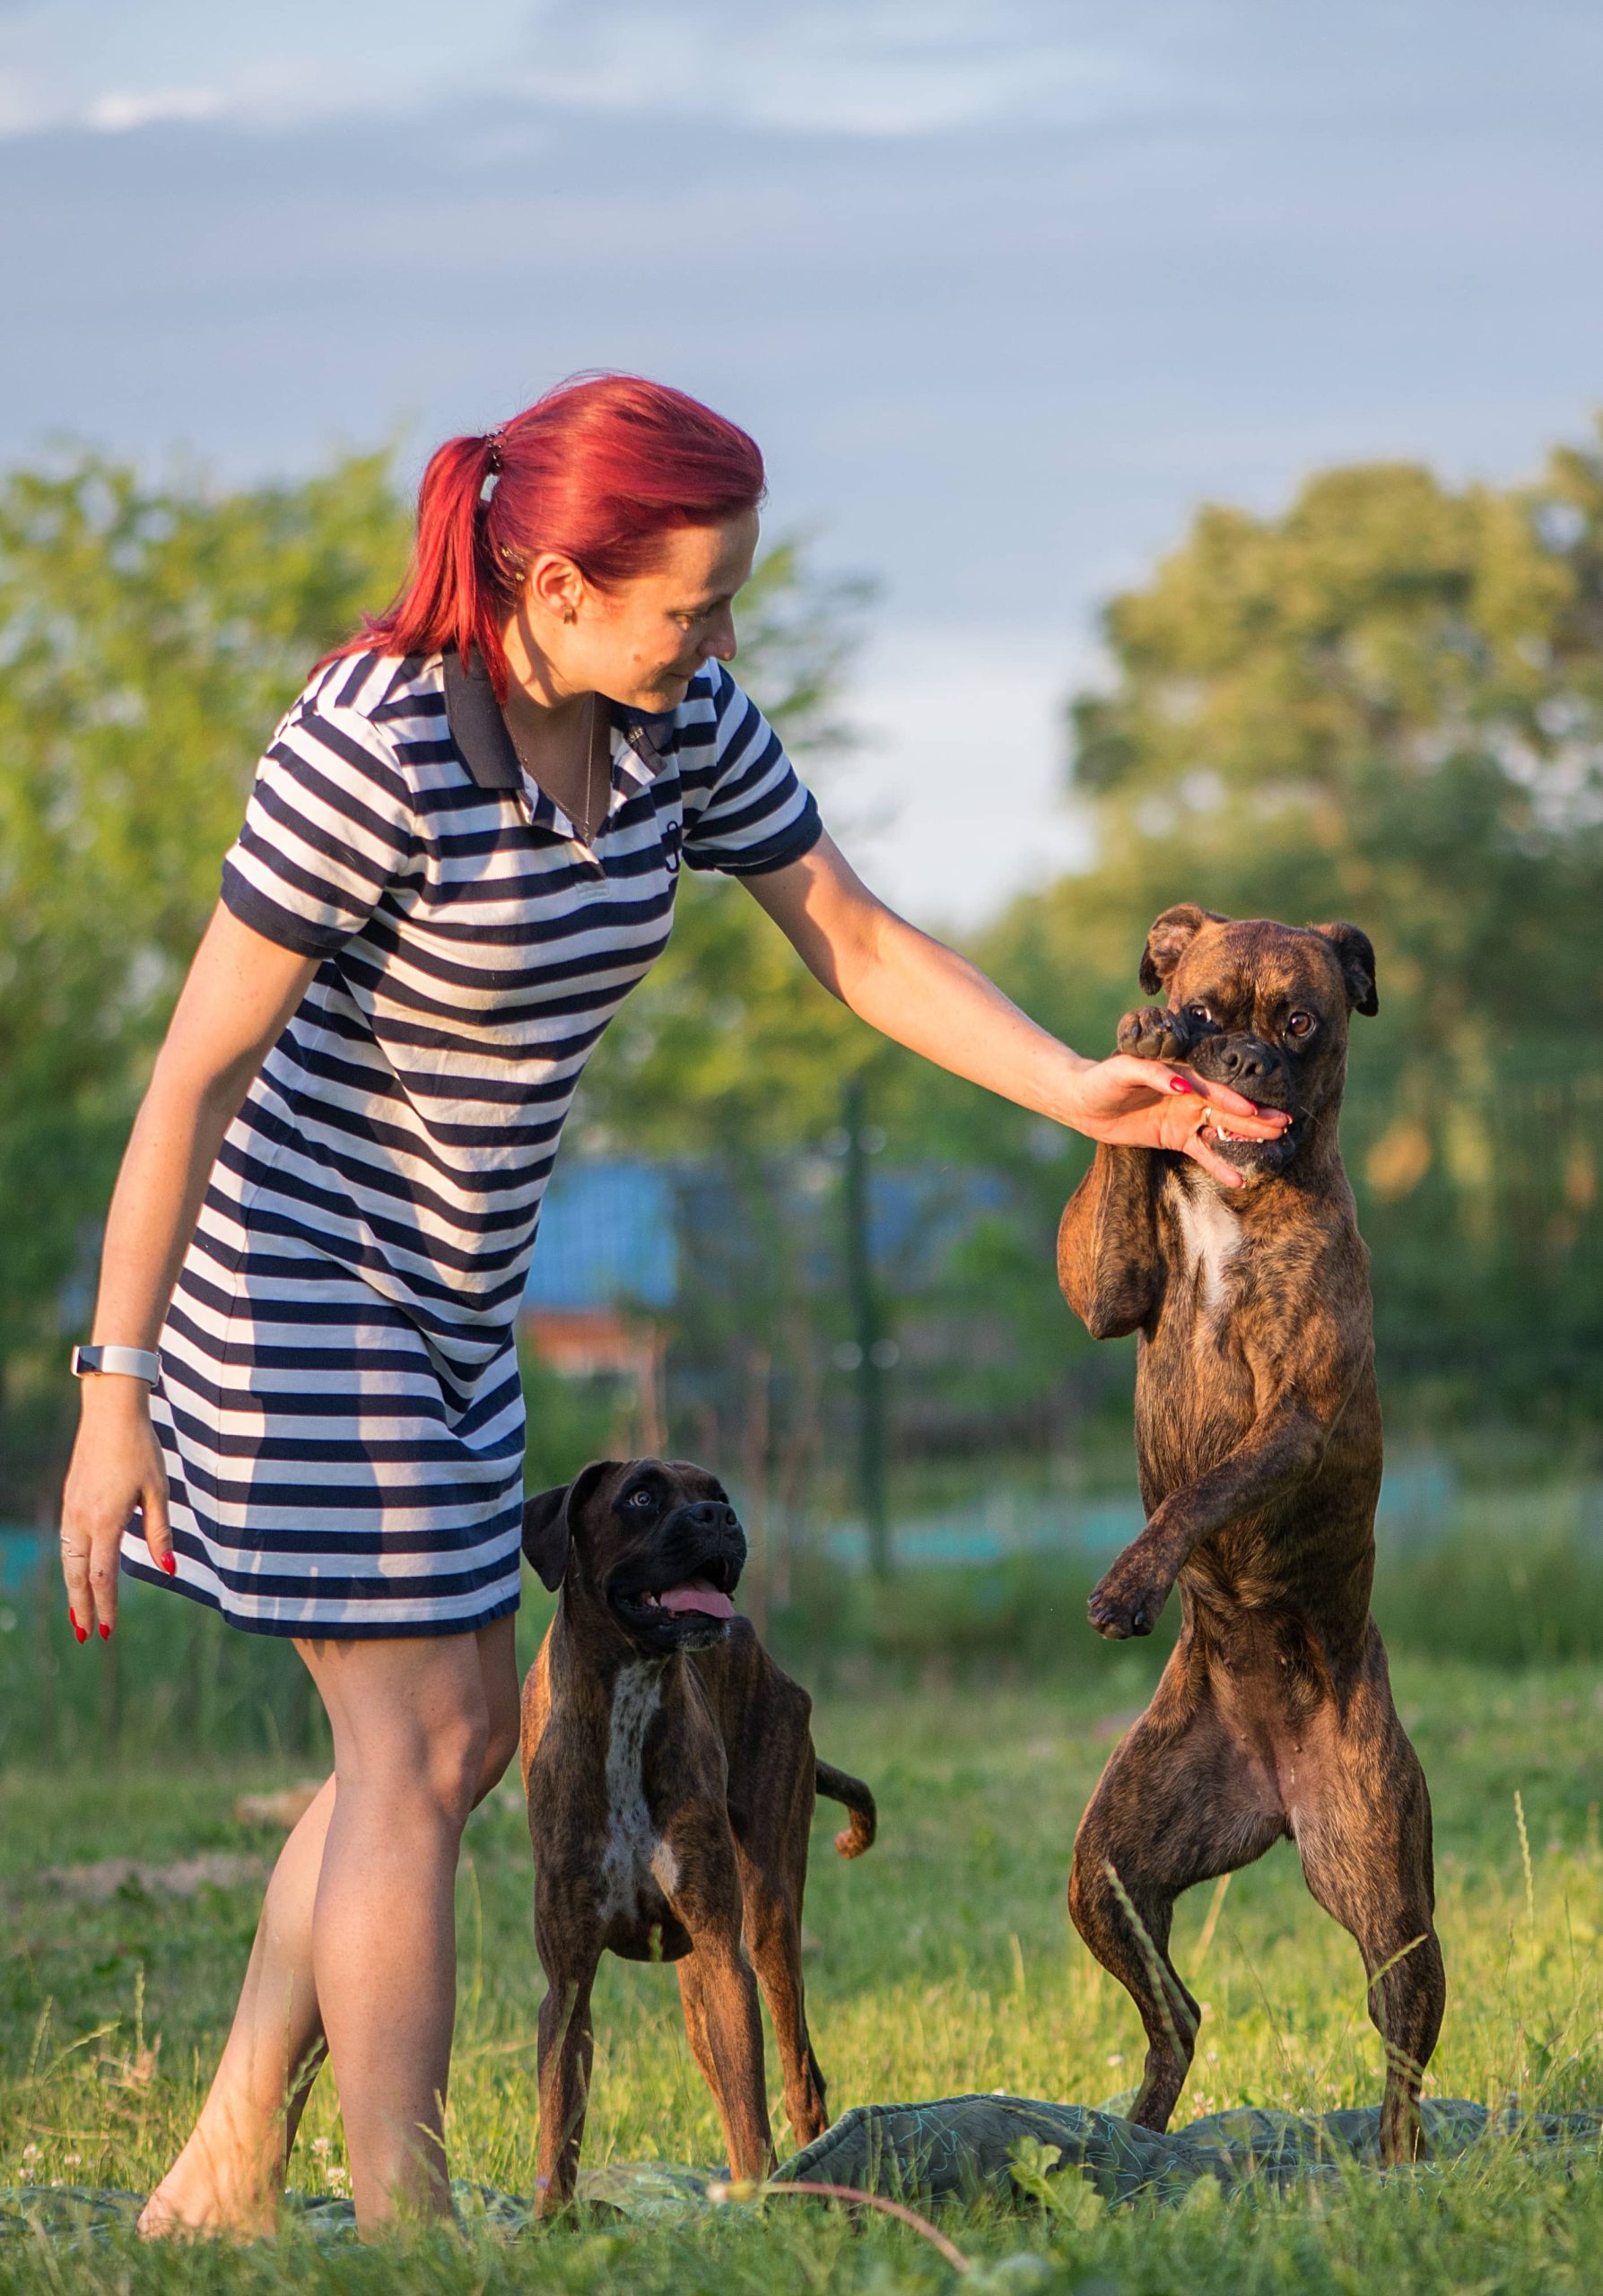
[677,664,824,877]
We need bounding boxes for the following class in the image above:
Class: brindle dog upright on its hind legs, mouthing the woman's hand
[1059,902,1447,2161]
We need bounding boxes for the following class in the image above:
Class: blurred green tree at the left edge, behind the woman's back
[0,452,409,1487]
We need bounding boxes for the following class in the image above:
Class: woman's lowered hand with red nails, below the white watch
[62,1370,175,1641]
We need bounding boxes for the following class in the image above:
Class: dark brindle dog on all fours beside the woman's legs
[524,1458,875,2213]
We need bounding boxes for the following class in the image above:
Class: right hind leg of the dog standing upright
[1288,1628,1447,2165]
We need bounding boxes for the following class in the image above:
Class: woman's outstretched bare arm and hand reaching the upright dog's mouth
[744,836,1286,1187]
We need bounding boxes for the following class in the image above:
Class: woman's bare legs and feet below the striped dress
[140,1619,517,2234]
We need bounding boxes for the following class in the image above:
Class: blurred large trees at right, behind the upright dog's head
[971,415,1603,1401]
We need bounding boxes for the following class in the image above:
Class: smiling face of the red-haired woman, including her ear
[519,509,758,709]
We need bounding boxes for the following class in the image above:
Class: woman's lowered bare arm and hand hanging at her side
[62,907,317,1641]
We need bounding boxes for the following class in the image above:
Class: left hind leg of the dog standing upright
[1067,1660,1286,2131]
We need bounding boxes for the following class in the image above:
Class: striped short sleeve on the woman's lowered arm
[222,693,411,958]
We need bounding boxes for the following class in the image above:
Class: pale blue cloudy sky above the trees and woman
[0,0,1603,927]
